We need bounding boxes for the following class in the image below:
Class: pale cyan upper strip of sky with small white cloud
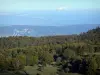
[0,0,100,12]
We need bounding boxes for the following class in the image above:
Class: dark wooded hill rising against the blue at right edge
[80,27,100,45]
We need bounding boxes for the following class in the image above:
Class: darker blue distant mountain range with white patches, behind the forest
[0,24,100,37]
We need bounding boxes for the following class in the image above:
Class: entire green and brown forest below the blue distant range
[0,27,100,75]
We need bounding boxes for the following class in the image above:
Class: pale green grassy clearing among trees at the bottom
[25,66,57,75]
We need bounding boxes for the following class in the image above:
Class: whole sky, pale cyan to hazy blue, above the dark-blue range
[0,0,100,26]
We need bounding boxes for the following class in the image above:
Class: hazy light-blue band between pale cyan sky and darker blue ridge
[0,10,100,26]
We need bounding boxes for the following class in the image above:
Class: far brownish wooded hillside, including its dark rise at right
[0,27,100,48]
